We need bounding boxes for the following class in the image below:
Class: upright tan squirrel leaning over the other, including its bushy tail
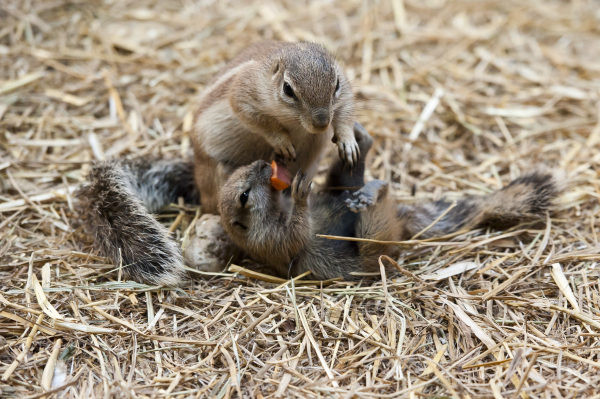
[78,42,360,285]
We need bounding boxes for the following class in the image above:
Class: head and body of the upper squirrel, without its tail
[192,42,359,213]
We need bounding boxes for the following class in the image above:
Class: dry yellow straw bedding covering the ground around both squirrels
[0,0,600,398]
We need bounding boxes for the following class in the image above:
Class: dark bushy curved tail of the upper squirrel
[77,159,198,285]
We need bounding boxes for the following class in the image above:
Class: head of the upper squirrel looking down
[271,43,352,134]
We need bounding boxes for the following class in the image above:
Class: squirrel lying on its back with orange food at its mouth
[219,129,559,279]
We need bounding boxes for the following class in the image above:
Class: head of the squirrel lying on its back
[219,160,278,239]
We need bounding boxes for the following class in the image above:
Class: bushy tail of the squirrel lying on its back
[398,172,560,239]
